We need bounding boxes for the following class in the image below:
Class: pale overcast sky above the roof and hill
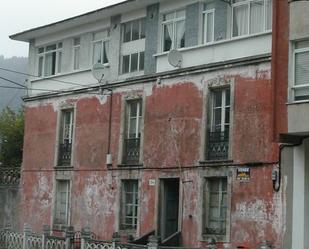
[0,0,124,58]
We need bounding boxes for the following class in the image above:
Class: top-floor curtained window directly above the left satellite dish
[92,31,109,64]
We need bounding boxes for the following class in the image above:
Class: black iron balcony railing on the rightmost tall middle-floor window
[207,131,229,160]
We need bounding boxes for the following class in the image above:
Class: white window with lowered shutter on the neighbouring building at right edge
[293,40,309,101]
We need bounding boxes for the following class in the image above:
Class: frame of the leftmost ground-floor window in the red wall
[53,179,71,226]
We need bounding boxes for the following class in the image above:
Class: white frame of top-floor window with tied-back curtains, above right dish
[161,9,186,53]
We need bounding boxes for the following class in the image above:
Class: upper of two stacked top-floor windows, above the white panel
[122,18,145,42]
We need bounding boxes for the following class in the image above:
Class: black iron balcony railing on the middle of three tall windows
[123,138,140,164]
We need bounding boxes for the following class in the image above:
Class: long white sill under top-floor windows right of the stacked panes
[153,31,272,57]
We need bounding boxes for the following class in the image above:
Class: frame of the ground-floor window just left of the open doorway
[120,179,140,231]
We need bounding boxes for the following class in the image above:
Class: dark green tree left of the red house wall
[0,107,24,167]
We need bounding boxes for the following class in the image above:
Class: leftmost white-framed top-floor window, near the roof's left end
[38,42,62,77]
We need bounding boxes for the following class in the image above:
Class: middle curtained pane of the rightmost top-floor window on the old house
[250,0,264,34]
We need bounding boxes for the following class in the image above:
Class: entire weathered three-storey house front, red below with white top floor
[12,0,286,248]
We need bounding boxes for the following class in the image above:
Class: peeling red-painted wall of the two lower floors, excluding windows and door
[21,62,284,248]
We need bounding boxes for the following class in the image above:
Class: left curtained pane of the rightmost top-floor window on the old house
[233,4,248,37]
